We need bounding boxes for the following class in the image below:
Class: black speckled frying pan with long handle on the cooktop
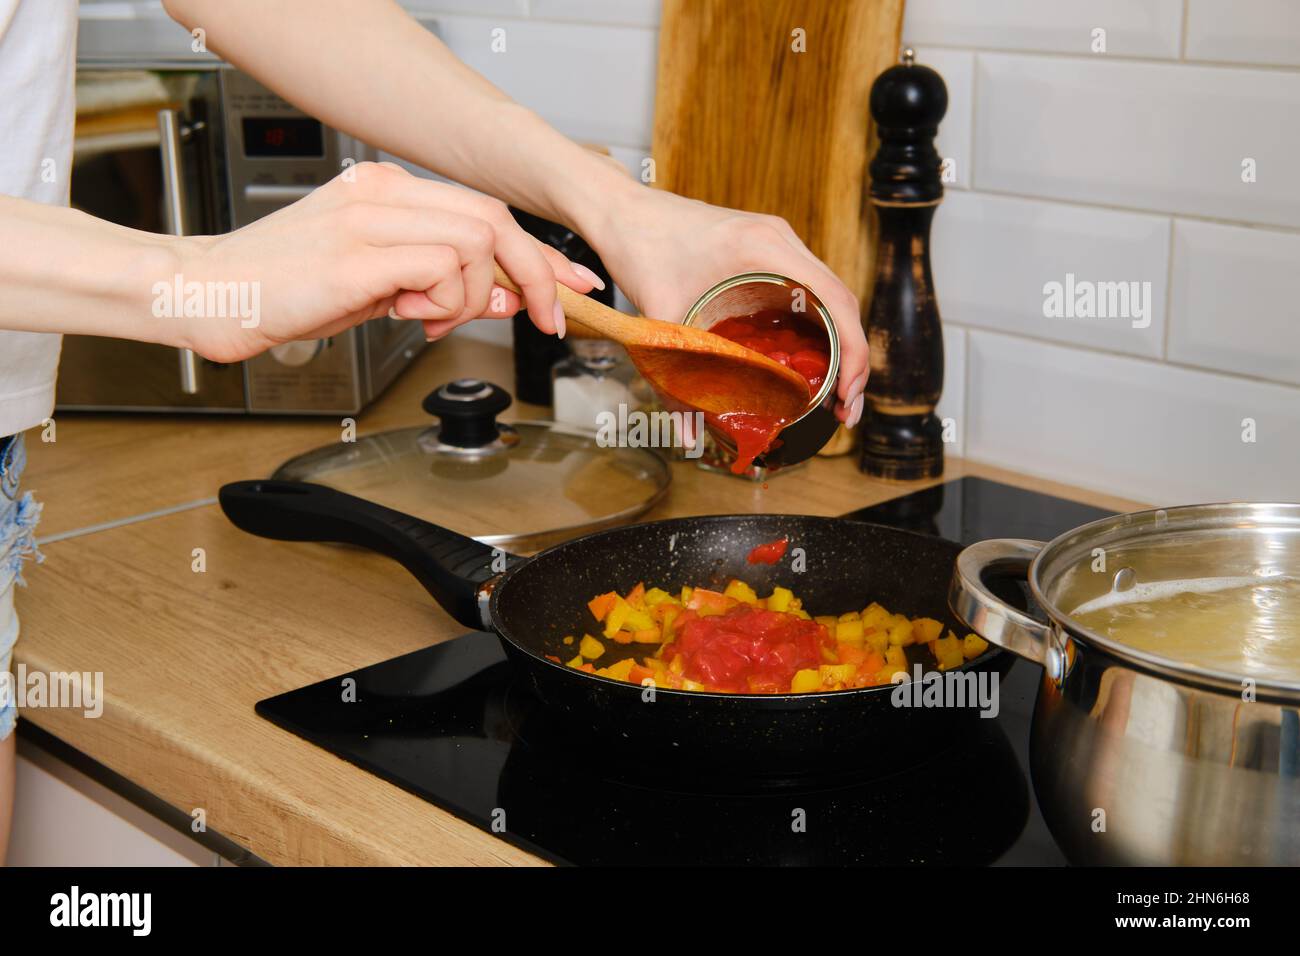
[220,480,1010,770]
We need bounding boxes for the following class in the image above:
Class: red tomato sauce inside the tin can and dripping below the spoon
[707,308,831,475]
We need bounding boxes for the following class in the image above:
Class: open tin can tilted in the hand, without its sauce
[681,272,840,468]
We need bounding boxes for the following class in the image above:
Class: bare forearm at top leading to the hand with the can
[165,0,634,241]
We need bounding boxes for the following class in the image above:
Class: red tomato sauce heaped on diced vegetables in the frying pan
[664,605,826,693]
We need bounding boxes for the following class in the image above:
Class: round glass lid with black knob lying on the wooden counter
[272,378,672,551]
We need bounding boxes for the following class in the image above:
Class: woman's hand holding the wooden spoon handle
[174,163,595,362]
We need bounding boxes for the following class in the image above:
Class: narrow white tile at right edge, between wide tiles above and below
[1169,220,1300,387]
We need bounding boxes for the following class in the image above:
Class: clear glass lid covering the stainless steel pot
[1030,502,1300,697]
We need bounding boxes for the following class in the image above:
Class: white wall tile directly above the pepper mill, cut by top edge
[904,0,1183,57]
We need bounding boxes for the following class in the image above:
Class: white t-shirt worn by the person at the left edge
[0,0,77,437]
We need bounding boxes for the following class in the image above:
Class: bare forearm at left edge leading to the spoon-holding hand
[0,196,187,345]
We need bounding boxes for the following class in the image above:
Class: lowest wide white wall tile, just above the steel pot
[966,330,1300,505]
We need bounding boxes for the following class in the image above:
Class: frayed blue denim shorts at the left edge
[0,434,42,740]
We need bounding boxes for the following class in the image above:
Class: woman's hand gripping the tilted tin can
[593,185,867,427]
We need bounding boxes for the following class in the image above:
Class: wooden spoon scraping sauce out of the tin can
[497,265,810,423]
